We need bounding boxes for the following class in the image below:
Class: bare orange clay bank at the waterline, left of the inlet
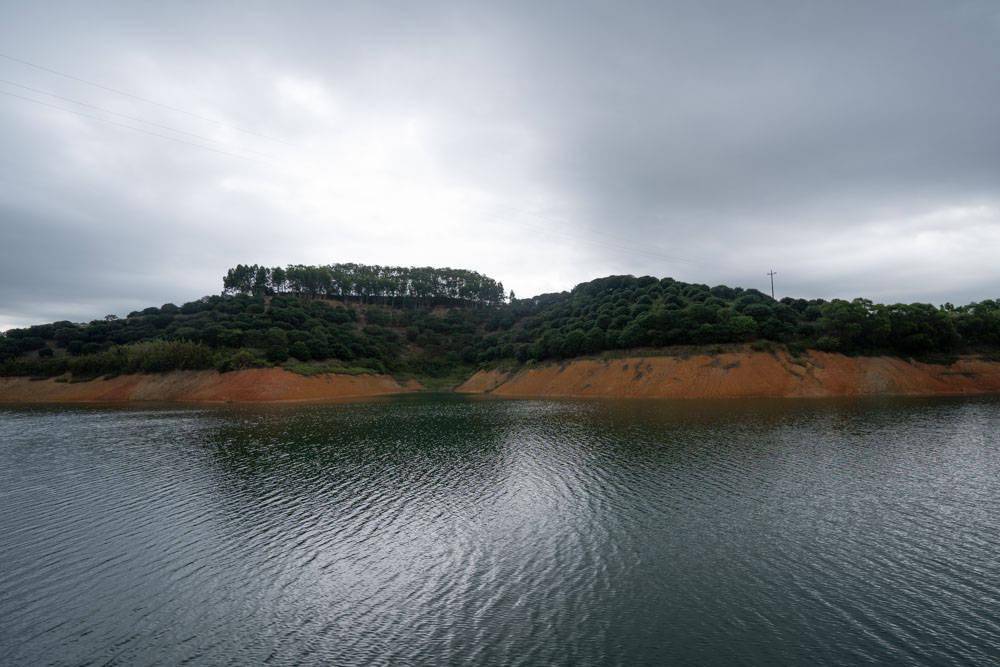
[0,368,422,403]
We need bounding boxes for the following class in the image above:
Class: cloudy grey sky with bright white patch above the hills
[0,0,1000,330]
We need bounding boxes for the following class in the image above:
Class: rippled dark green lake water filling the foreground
[0,397,1000,665]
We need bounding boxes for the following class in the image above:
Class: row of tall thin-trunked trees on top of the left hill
[222,263,506,306]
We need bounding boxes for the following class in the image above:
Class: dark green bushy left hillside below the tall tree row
[0,295,489,375]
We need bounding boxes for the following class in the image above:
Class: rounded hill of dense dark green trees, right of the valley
[485,276,1000,361]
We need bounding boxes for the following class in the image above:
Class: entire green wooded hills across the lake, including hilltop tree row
[0,264,1000,378]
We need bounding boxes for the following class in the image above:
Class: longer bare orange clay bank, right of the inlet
[456,350,1000,398]
